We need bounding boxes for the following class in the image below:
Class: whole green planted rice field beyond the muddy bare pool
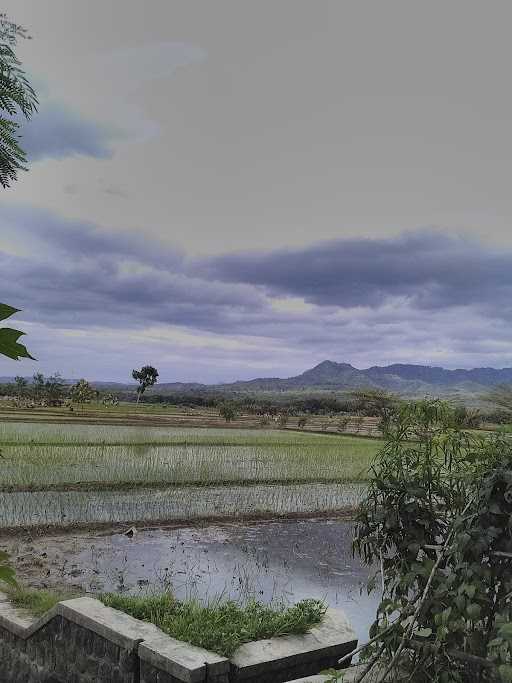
[0,423,381,528]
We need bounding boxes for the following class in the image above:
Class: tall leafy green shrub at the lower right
[354,401,512,683]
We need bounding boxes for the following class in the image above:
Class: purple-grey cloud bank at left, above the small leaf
[0,208,264,330]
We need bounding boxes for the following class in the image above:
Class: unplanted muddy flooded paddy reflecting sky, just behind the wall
[0,519,378,640]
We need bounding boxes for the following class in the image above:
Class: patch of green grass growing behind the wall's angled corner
[101,593,326,657]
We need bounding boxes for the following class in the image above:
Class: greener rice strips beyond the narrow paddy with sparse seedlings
[0,424,382,491]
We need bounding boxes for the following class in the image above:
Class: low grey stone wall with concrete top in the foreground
[0,593,356,683]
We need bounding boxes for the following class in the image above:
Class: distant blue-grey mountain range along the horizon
[4,360,512,396]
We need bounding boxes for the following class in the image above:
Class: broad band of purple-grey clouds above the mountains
[0,207,512,381]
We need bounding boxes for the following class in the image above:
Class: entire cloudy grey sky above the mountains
[0,0,512,383]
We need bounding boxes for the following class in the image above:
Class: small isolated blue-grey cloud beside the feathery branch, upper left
[20,103,115,161]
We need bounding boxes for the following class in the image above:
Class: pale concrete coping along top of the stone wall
[0,592,357,683]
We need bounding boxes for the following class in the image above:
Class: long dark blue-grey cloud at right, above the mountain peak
[201,230,512,314]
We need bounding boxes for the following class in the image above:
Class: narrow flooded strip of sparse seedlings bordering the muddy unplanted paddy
[0,483,365,528]
